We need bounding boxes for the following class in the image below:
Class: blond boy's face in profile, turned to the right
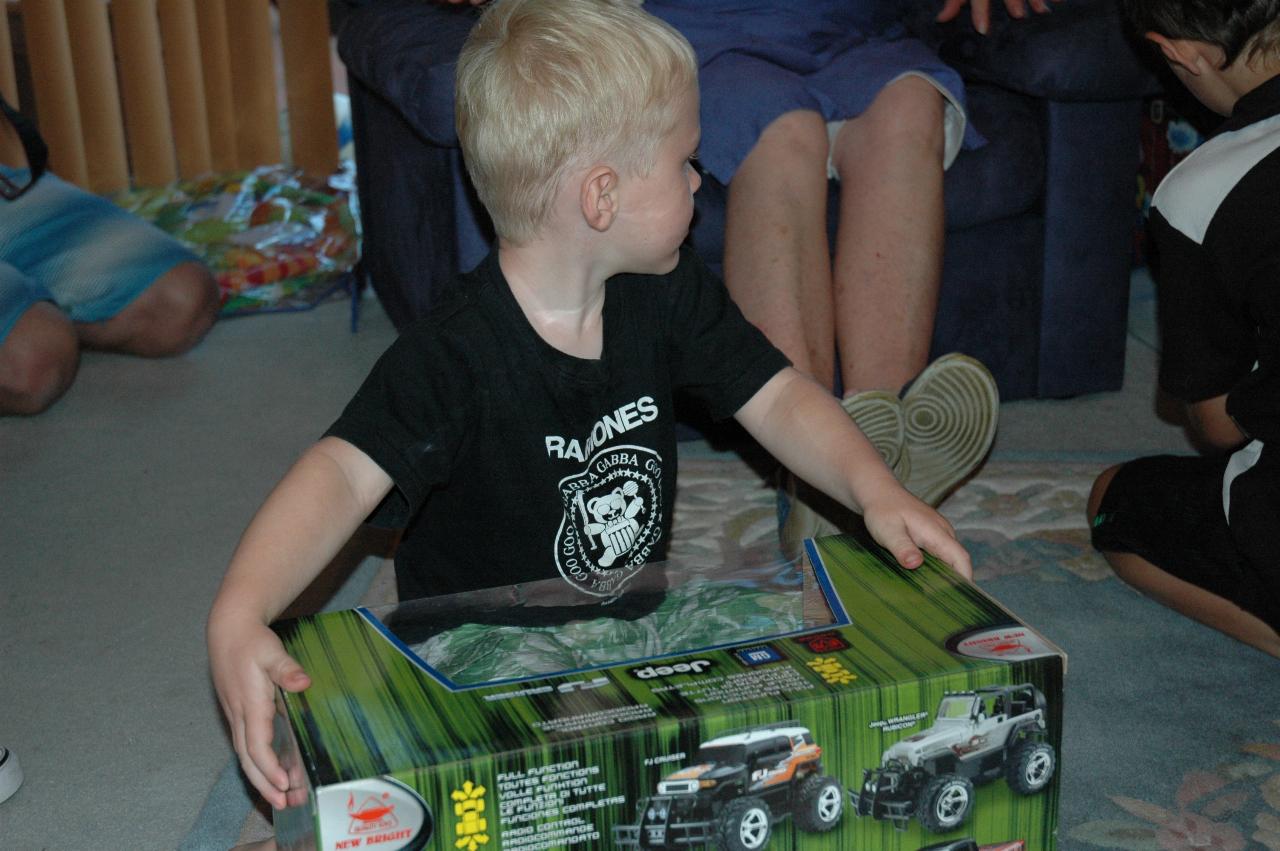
[616,90,703,275]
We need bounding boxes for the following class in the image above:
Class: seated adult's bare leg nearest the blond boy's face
[724,110,835,388]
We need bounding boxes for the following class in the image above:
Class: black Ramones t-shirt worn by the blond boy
[326,241,787,600]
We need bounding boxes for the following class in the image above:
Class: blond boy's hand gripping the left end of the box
[209,619,311,809]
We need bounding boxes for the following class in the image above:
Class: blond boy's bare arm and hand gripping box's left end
[207,438,392,807]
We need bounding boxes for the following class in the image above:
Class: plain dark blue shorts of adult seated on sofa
[645,0,984,186]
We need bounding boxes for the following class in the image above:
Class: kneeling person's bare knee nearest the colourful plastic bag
[134,262,218,357]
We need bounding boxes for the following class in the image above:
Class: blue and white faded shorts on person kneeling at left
[0,166,200,343]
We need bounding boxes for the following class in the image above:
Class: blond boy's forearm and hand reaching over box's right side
[735,367,973,578]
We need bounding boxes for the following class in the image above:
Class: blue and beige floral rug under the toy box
[225,441,1280,851]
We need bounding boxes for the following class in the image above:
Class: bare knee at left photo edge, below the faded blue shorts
[0,302,79,415]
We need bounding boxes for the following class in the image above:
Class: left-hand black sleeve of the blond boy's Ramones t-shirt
[325,325,471,529]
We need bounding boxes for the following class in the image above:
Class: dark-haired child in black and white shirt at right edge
[1088,0,1280,656]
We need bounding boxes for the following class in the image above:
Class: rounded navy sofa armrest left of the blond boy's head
[338,0,479,147]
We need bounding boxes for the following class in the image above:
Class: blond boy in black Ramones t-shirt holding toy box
[209,0,972,806]
